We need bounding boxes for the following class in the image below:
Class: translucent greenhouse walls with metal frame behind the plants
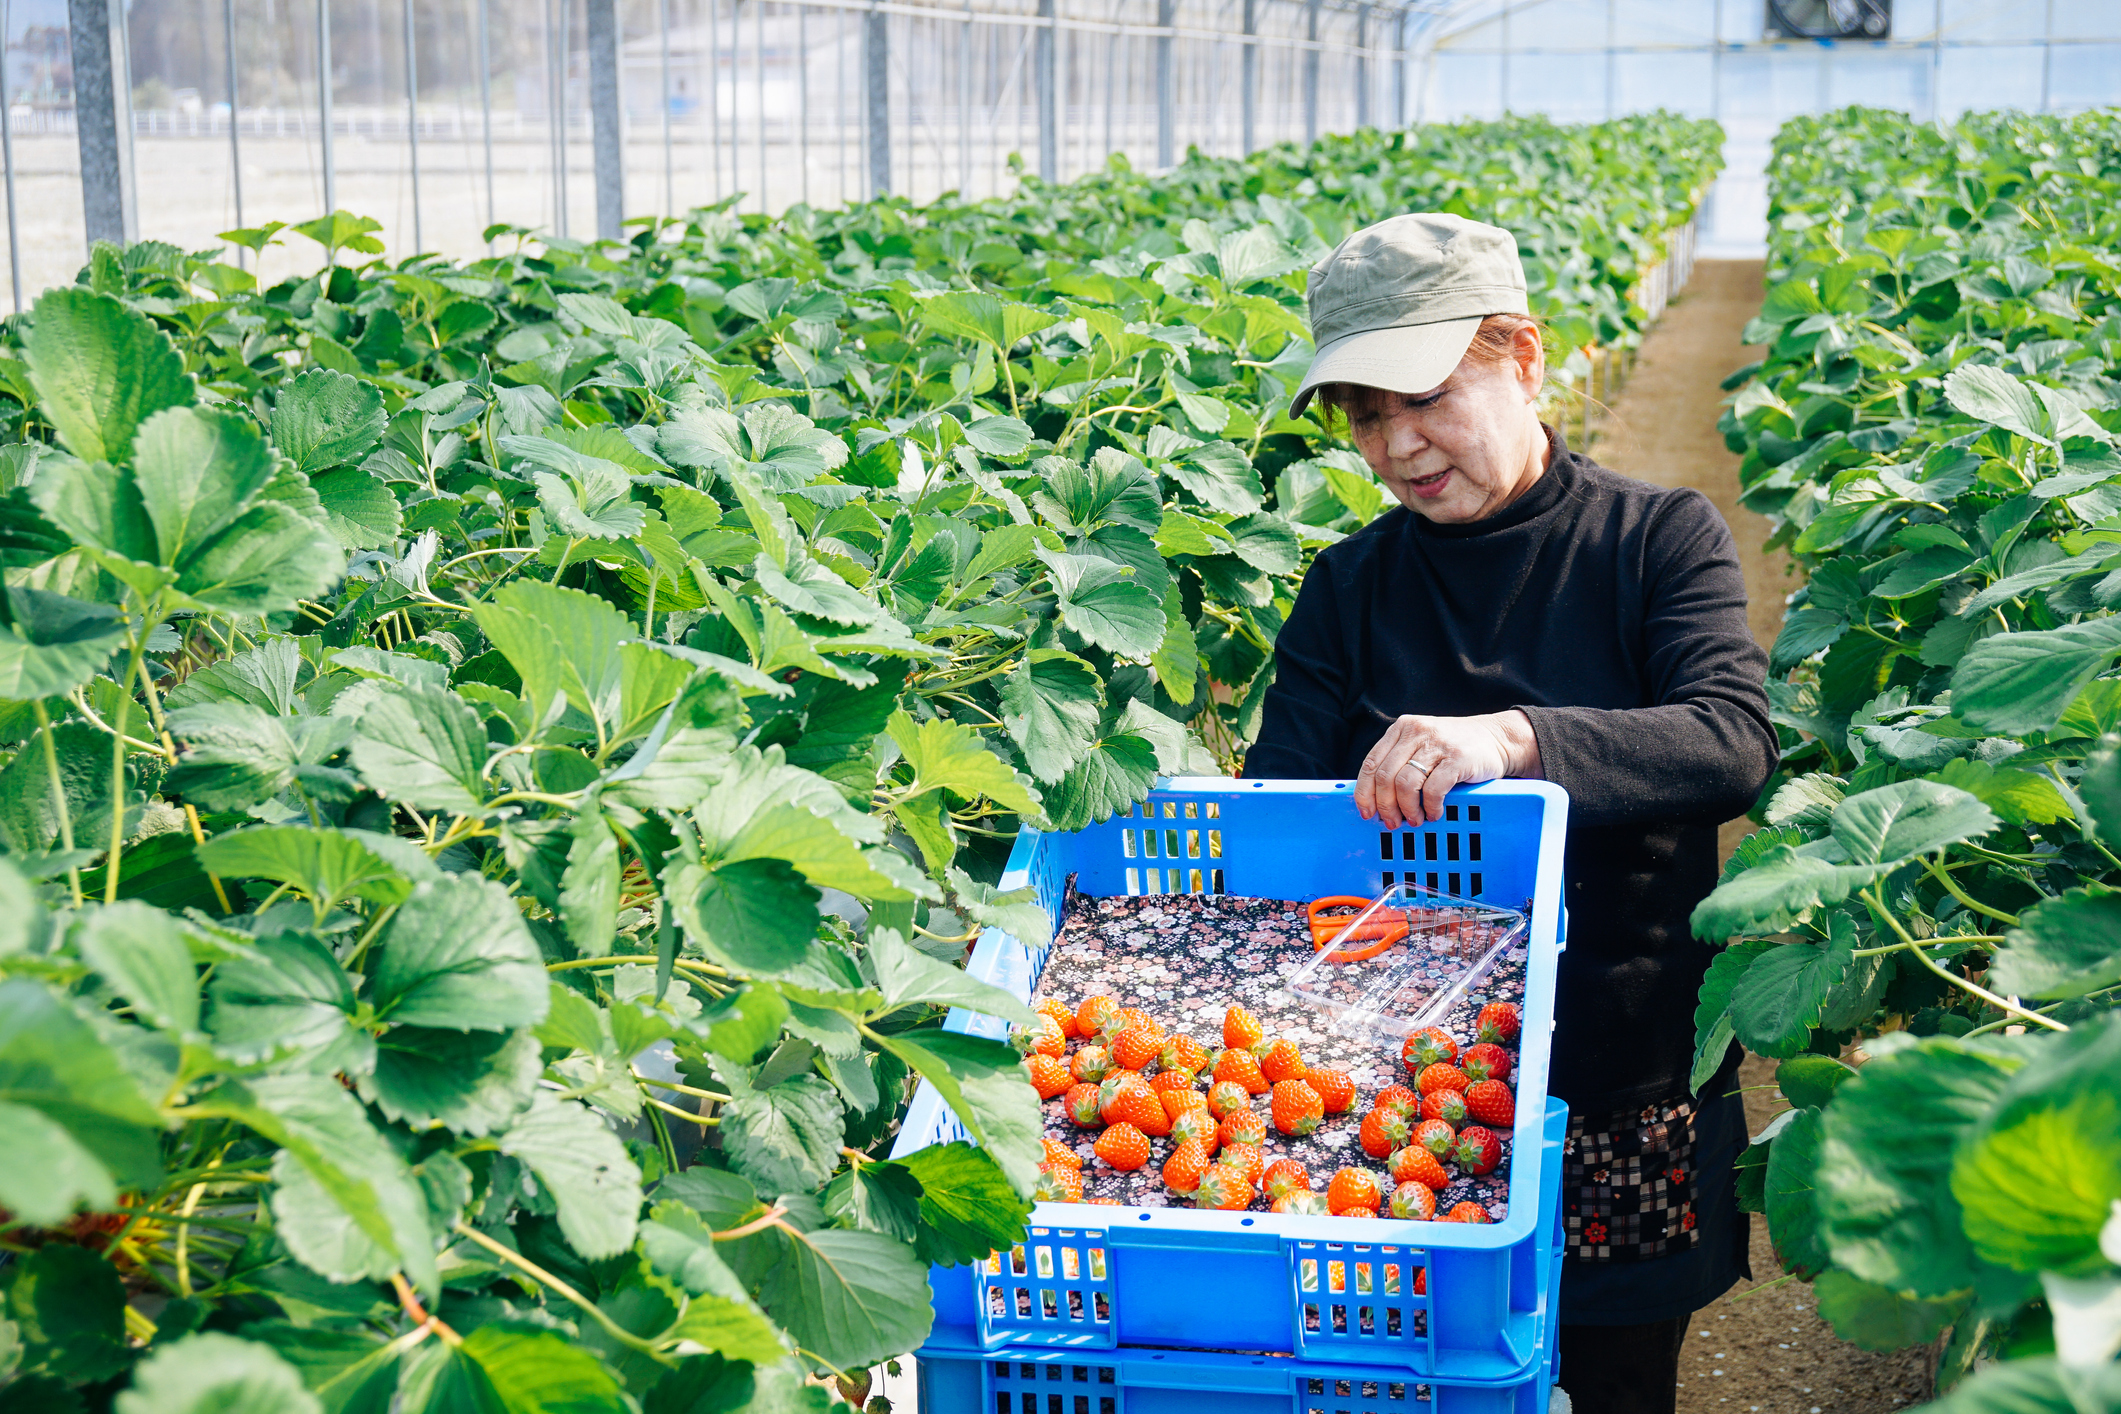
[0,0,2121,292]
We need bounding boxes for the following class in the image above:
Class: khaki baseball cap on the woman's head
[1290,212,1531,418]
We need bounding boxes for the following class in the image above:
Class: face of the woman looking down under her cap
[1347,329,1546,526]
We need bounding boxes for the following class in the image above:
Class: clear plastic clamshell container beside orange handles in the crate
[1283,884,1529,1047]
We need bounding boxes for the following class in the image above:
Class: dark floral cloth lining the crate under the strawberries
[1033,886,1527,1221]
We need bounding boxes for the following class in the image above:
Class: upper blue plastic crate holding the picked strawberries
[893,778,1567,1382]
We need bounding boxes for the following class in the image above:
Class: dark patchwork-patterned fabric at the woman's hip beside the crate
[1561,1098,1699,1261]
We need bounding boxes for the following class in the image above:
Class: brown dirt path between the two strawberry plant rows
[1594,261,1928,1414]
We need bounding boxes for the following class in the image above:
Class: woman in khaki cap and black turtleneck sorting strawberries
[1245,214,1775,1414]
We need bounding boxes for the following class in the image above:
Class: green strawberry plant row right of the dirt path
[1695,110,2121,1414]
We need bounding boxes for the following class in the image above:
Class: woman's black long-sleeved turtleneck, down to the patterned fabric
[1245,430,1777,1113]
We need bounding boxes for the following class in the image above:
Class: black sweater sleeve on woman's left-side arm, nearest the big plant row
[1245,555,1349,780]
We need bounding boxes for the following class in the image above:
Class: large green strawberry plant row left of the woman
[0,119,1718,1414]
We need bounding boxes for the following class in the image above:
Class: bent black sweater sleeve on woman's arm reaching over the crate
[1523,492,1780,827]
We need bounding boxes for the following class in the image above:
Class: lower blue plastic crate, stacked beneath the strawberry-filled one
[918,1344,1553,1414]
